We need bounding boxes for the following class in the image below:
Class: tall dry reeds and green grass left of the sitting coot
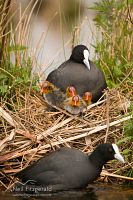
[0,0,36,102]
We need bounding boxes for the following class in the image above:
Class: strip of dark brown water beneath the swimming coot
[0,184,133,200]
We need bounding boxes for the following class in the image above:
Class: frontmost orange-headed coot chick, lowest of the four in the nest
[63,95,86,115]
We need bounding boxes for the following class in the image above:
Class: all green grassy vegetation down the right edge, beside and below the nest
[92,0,133,183]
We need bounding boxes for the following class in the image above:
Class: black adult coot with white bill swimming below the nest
[17,143,124,191]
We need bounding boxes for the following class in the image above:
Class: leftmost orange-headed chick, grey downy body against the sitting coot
[40,81,65,107]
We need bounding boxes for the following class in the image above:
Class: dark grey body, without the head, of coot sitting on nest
[47,60,106,101]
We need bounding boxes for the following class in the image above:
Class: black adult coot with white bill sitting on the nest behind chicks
[47,45,107,102]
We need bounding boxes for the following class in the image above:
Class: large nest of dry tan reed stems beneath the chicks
[0,89,133,189]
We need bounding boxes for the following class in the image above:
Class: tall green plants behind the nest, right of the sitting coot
[93,0,133,87]
